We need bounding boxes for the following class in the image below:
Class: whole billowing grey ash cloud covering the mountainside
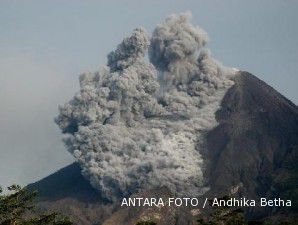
[56,14,234,200]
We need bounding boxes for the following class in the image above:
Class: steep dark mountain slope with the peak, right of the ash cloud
[205,72,298,217]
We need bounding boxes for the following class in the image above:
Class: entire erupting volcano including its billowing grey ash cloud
[29,13,298,225]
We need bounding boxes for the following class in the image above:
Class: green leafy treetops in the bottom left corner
[0,185,73,225]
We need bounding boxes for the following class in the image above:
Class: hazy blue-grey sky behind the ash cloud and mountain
[0,0,298,190]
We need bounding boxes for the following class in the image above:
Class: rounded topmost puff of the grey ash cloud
[149,12,208,71]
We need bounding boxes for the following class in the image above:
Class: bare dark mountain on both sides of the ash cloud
[28,72,298,225]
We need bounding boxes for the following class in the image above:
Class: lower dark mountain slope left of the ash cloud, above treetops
[27,163,113,225]
